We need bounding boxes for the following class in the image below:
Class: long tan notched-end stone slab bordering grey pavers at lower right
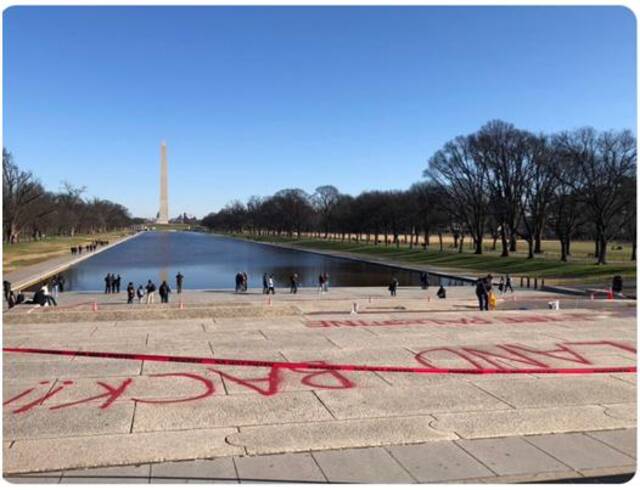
[431,405,629,439]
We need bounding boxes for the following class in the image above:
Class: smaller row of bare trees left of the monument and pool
[2,148,132,243]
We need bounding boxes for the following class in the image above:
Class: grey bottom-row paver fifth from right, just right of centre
[313,448,413,483]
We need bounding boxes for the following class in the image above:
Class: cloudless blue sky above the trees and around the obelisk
[3,7,636,217]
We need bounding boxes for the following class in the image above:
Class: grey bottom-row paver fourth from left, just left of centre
[235,453,327,483]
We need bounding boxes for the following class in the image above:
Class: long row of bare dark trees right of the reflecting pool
[201,120,636,264]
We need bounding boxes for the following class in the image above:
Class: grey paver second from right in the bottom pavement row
[527,434,635,472]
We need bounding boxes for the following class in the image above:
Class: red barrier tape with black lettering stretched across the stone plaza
[2,347,636,374]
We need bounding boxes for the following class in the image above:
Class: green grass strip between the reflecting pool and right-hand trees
[239,236,636,286]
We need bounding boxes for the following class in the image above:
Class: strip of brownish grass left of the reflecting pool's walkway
[2,231,130,274]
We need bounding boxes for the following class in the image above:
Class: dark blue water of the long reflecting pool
[64,232,470,291]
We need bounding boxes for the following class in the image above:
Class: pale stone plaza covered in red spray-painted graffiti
[3,287,636,483]
